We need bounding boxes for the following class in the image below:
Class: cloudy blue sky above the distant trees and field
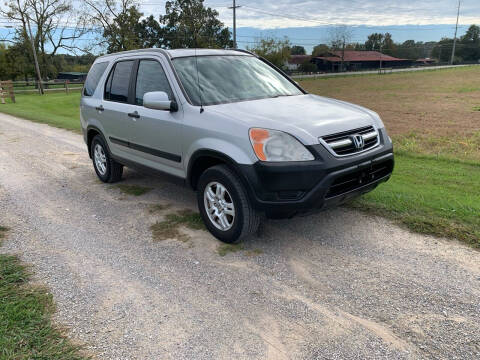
[0,0,480,51]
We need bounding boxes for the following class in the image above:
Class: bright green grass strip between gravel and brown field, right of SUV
[352,152,480,247]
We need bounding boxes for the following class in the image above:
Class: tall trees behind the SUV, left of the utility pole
[0,0,233,79]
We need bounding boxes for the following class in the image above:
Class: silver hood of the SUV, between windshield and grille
[208,94,383,145]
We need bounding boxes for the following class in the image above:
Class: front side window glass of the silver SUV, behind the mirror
[135,60,173,105]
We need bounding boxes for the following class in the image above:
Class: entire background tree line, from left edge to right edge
[0,0,480,79]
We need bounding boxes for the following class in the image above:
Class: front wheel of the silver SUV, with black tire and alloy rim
[197,165,260,244]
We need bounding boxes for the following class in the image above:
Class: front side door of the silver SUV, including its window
[127,58,184,177]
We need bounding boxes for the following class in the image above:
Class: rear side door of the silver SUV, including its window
[99,60,137,159]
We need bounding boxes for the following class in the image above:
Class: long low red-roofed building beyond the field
[313,50,413,72]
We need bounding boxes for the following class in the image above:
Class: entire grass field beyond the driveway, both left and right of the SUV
[0,66,480,247]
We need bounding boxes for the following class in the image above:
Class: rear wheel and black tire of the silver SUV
[90,135,123,183]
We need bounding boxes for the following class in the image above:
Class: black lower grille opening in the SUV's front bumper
[325,160,393,199]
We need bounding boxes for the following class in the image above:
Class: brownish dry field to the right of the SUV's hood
[301,66,480,161]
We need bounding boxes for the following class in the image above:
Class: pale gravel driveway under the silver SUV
[0,113,480,359]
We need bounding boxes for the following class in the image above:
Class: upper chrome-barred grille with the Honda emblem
[320,126,380,156]
